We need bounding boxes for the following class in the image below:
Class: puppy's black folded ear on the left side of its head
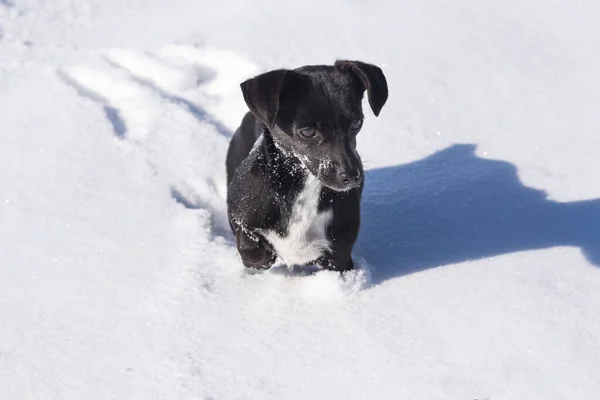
[240,69,294,129]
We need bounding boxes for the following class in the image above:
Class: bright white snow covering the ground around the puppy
[0,0,600,400]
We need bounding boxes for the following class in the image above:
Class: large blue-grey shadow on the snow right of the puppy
[356,145,600,283]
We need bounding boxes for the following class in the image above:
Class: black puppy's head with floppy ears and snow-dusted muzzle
[241,61,388,191]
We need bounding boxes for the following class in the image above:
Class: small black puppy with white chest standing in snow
[227,61,388,271]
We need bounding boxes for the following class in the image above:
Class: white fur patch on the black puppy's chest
[265,174,333,266]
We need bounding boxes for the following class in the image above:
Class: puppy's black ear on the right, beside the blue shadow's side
[334,60,388,116]
